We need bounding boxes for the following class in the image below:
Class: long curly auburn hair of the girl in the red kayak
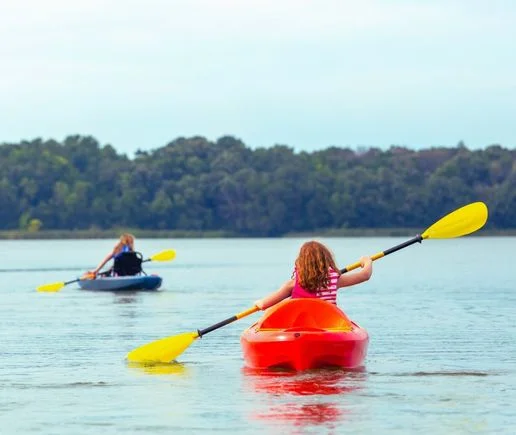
[296,241,340,293]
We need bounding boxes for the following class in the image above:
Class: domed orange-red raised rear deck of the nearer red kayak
[257,298,352,330]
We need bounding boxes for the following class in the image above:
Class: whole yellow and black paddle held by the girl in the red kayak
[127,202,487,363]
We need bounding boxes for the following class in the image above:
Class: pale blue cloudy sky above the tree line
[0,0,516,154]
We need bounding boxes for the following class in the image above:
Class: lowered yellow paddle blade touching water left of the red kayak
[127,331,199,363]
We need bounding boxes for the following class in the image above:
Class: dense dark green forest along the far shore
[0,136,516,237]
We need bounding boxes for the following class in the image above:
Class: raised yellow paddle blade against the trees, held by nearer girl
[421,202,488,239]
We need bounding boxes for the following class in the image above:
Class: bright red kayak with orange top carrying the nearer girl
[240,298,369,371]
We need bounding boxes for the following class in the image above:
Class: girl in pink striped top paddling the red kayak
[255,241,373,310]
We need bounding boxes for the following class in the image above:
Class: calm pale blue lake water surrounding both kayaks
[0,237,516,434]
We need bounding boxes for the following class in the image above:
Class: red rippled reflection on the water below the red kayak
[242,368,367,426]
